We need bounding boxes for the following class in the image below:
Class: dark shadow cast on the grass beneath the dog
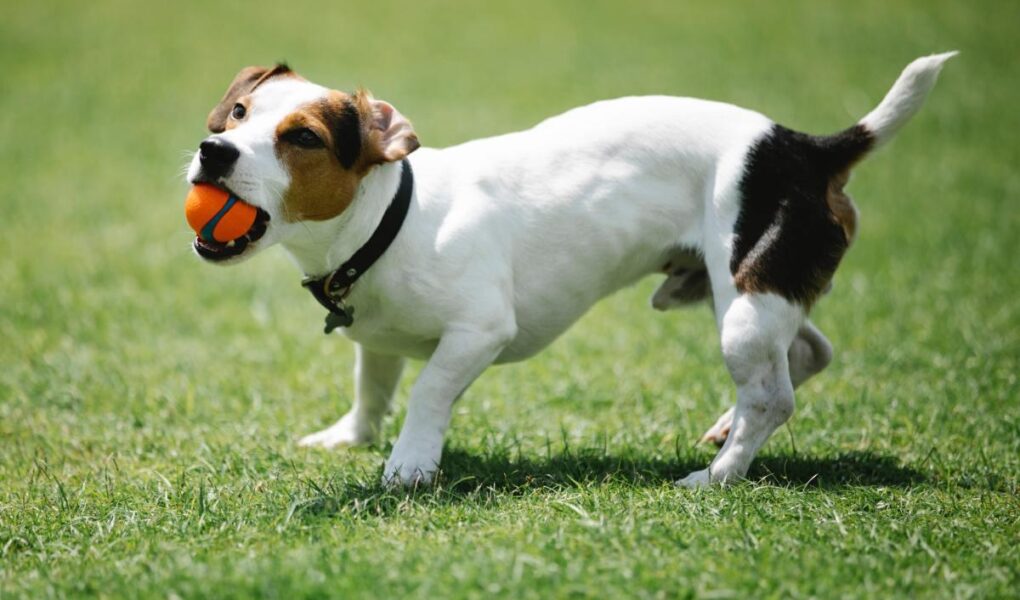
[288,448,926,520]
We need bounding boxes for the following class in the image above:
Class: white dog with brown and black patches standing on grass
[187,52,956,487]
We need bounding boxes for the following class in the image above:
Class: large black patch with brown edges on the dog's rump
[729,124,874,305]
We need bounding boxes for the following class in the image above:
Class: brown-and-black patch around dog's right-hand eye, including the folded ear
[275,90,418,221]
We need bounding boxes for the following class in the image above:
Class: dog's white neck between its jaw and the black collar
[281,161,401,277]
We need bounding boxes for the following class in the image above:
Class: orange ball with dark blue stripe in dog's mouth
[185,184,258,244]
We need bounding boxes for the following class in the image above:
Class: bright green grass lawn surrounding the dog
[0,0,1020,598]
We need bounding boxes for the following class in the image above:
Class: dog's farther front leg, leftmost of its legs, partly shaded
[298,344,404,448]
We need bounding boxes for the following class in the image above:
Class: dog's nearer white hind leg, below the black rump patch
[677,291,804,487]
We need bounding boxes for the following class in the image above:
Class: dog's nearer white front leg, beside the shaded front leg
[383,327,514,486]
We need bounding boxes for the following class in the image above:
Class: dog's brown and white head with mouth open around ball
[188,64,418,263]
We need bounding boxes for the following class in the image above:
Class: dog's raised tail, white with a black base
[817,51,958,172]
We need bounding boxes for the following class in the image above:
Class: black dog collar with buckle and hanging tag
[301,158,414,334]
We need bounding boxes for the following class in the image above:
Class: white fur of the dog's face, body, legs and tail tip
[189,55,946,485]
